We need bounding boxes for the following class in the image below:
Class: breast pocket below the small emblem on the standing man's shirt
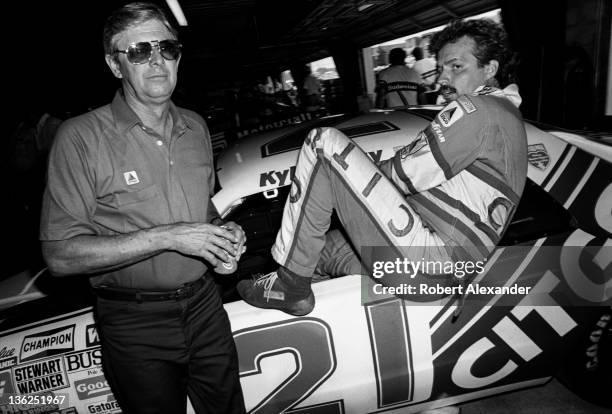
[96,185,170,233]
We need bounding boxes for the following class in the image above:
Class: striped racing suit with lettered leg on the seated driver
[272,85,527,292]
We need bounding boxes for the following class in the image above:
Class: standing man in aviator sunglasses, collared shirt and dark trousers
[41,3,245,414]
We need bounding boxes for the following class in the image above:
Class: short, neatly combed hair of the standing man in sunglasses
[102,2,178,55]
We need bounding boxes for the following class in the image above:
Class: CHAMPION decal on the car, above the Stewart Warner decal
[20,325,74,362]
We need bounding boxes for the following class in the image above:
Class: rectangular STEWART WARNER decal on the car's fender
[13,357,70,394]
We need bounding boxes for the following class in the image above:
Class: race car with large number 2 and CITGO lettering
[0,107,612,414]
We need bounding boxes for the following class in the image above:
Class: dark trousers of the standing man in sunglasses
[96,277,245,414]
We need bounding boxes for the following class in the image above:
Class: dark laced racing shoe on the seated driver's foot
[236,270,315,316]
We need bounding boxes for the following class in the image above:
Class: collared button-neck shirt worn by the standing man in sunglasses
[40,92,218,290]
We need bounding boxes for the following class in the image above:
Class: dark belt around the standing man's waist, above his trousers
[93,276,206,302]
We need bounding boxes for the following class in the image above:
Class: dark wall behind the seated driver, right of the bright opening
[500,0,612,129]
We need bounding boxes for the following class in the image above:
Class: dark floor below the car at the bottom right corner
[461,379,612,414]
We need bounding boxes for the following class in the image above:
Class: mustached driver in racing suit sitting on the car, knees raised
[238,20,527,316]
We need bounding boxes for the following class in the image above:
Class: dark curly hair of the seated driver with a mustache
[429,19,518,88]
